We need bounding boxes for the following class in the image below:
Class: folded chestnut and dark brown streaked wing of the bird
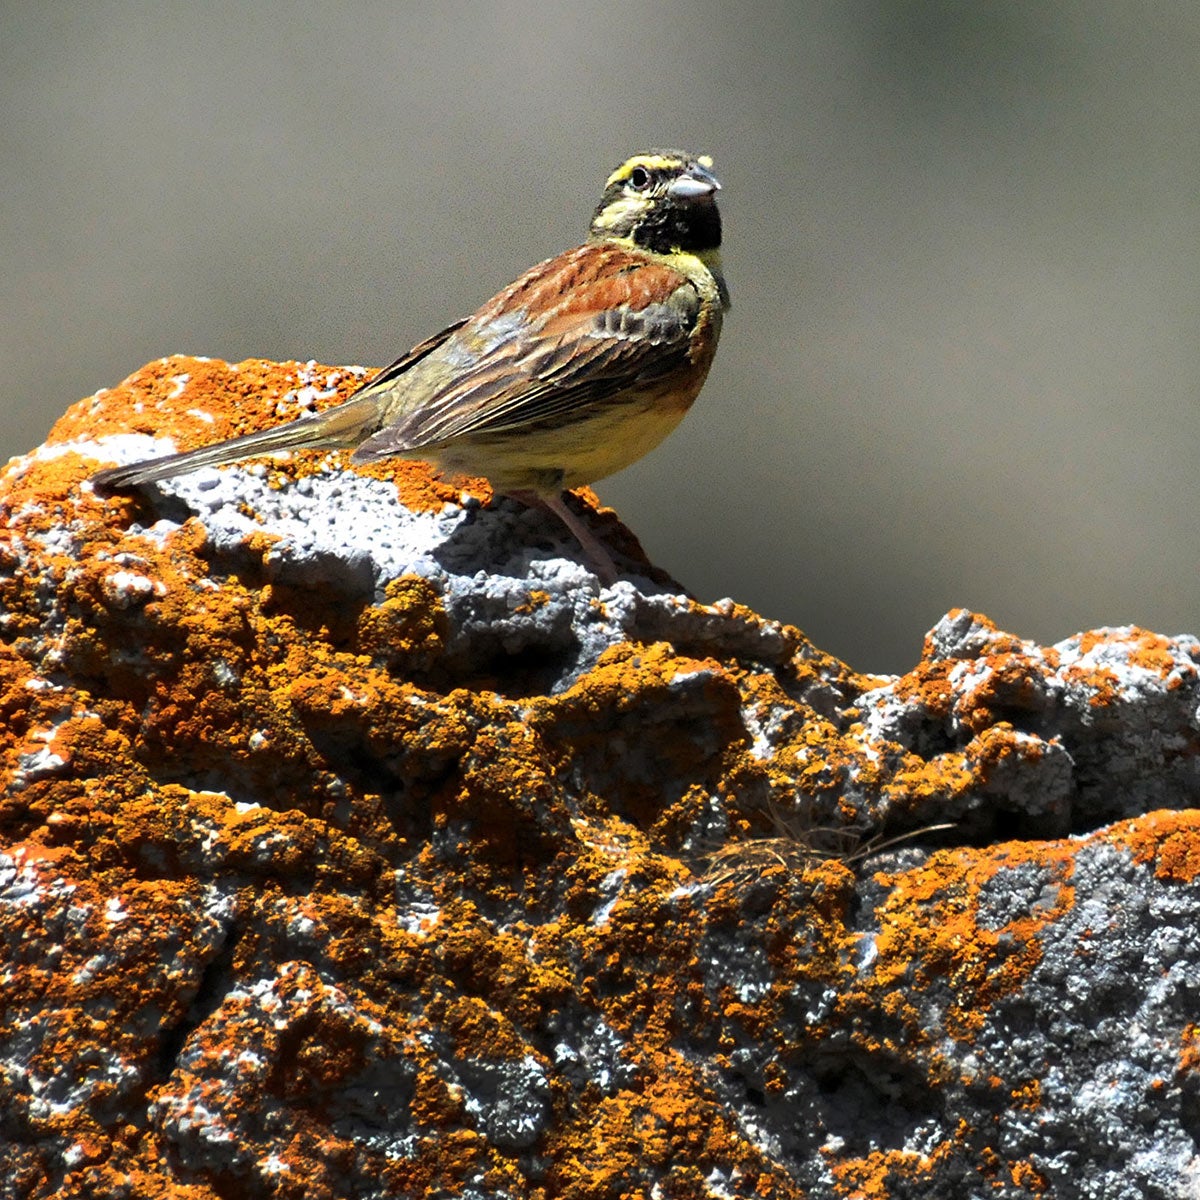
[355,245,701,461]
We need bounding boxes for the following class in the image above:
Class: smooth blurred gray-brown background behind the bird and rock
[0,0,1200,671]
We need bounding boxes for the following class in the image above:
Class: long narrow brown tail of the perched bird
[91,396,379,491]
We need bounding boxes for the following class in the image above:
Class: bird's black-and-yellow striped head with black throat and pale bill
[592,150,721,254]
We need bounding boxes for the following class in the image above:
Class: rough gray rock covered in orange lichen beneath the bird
[0,359,1200,1200]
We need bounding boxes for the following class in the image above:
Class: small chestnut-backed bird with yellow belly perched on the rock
[92,150,730,584]
